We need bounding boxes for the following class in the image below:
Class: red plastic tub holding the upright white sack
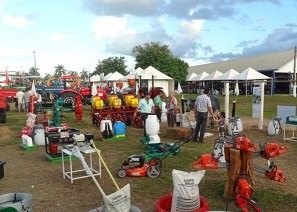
[155,194,209,212]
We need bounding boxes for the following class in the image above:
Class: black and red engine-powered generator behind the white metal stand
[45,128,80,158]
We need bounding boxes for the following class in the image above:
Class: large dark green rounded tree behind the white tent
[132,42,189,82]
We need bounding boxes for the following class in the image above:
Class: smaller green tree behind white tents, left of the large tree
[91,57,127,75]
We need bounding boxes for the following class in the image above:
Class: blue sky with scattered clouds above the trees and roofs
[0,0,297,75]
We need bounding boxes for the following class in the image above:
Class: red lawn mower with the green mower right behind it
[117,131,194,178]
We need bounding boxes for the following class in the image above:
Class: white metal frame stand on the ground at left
[62,147,101,183]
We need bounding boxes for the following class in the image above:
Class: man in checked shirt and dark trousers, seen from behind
[194,88,213,143]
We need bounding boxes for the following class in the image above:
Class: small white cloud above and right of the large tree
[179,19,204,39]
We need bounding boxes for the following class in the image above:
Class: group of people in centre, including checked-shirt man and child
[134,88,226,143]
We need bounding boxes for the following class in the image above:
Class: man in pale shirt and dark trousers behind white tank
[134,92,154,137]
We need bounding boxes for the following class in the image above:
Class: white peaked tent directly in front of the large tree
[138,66,174,95]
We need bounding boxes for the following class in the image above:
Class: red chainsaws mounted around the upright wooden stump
[193,136,288,212]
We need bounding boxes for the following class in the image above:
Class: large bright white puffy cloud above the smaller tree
[92,16,135,38]
